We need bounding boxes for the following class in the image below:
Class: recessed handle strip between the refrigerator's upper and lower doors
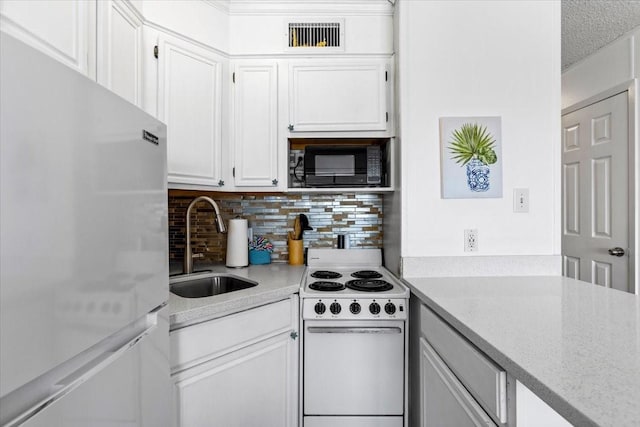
[0,303,166,427]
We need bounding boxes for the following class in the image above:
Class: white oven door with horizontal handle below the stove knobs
[303,320,405,416]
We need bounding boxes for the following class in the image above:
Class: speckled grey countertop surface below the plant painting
[404,276,640,427]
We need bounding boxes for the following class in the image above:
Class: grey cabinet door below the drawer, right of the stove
[420,338,496,427]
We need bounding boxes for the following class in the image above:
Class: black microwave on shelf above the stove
[304,145,385,187]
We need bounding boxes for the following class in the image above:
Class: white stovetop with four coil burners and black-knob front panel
[300,248,409,320]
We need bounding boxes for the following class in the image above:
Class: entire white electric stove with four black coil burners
[300,248,409,427]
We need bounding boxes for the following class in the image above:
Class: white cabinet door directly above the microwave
[289,60,388,132]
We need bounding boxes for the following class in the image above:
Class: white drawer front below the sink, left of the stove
[169,297,297,373]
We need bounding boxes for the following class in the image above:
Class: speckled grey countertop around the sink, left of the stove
[169,263,305,330]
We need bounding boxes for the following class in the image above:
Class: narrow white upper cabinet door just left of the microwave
[233,61,279,190]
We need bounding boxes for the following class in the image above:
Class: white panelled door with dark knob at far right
[562,92,630,291]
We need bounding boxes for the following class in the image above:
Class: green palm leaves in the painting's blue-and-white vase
[449,123,498,166]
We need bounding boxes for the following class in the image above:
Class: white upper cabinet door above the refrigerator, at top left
[0,0,96,78]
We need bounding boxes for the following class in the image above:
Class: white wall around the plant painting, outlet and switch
[398,0,560,273]
